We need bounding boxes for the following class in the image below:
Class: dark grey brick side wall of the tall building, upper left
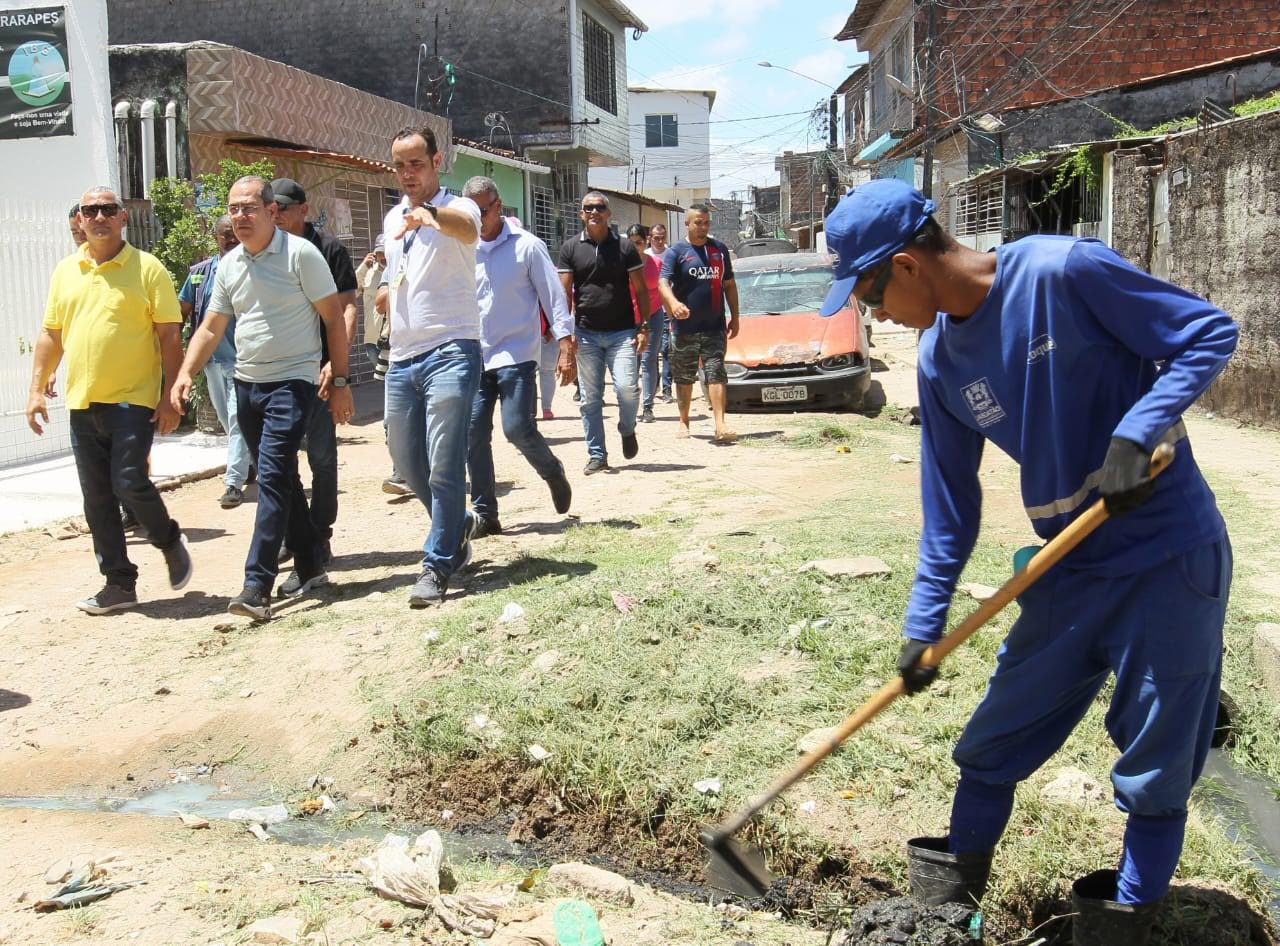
[109,0,570,147]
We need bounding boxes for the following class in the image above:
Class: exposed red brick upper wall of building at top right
[926,0,1280,119]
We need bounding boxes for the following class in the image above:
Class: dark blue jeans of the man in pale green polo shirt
[236,378,320,594]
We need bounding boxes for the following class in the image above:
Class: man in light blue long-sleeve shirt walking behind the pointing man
[462,177,577,538]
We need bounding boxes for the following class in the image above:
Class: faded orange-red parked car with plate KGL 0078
[724,252,872,411]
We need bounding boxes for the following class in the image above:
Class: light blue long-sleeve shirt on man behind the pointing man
[476,219,573,371]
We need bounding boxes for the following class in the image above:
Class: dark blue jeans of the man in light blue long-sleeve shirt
[467,361,564,518]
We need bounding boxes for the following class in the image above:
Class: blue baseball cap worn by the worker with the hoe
[818,178,934,315]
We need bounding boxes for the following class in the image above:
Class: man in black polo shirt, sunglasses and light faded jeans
[558,191,650,476]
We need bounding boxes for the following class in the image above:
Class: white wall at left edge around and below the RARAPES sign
[0,0,115,466]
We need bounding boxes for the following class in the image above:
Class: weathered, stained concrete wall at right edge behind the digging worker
[1111,111,1280,428]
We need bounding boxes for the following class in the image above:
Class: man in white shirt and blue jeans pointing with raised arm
[383,127,481,608]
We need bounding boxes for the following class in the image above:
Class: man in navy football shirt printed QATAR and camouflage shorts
[658,204,737,443]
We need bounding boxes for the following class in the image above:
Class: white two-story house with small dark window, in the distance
[590,86,716,207]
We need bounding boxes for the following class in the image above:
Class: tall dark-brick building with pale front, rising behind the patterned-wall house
[103,0,646,252]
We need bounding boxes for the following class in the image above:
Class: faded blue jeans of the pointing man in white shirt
[387,339,481,581]
